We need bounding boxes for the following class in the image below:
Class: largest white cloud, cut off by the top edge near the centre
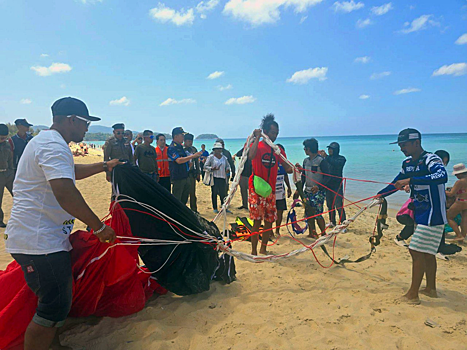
[223,0,323,26]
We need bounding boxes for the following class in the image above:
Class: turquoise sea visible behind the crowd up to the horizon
[88,133,467,208]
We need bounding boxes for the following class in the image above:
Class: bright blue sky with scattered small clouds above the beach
[0,0,467,138]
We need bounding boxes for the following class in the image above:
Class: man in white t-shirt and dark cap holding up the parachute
[4,97,120,350]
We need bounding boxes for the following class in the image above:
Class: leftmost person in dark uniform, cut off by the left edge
[0,124,15,228]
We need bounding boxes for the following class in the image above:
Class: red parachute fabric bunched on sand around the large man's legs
[0,206,167,349]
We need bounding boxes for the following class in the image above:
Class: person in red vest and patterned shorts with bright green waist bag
[248,114,292,255]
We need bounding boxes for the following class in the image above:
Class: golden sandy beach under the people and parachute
[0,150,467,350]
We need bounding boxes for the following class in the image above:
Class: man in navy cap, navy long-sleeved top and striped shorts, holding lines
[378,129,448,304]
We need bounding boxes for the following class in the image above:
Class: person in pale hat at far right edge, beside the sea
[446,163,467,242]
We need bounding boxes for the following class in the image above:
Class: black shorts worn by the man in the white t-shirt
[11,252,73,327]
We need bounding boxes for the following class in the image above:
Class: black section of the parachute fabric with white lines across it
[112,164,235,295]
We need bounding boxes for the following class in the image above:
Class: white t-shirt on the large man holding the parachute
[4,130,75,255]
